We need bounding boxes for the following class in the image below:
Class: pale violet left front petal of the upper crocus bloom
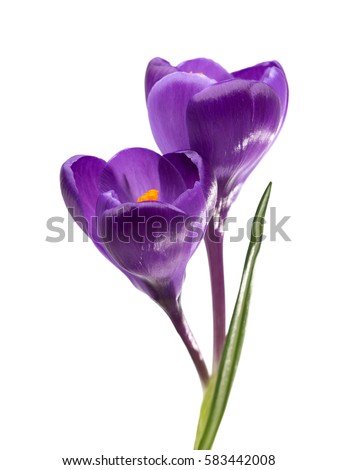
[147,72,214,153]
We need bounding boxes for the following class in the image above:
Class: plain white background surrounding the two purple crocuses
[0,0,338,470]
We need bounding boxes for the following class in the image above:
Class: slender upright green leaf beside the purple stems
[194,183,272,450]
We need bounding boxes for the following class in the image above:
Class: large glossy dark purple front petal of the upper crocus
[187,79,281,212]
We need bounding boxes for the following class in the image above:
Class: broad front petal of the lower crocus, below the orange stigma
[99,202,193,295]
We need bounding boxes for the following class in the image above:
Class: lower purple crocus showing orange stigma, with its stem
[61,148,215,385]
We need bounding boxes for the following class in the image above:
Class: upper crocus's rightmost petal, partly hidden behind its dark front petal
[232,61,289,127]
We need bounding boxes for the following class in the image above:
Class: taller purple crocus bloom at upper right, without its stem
[145,58,288,226]
